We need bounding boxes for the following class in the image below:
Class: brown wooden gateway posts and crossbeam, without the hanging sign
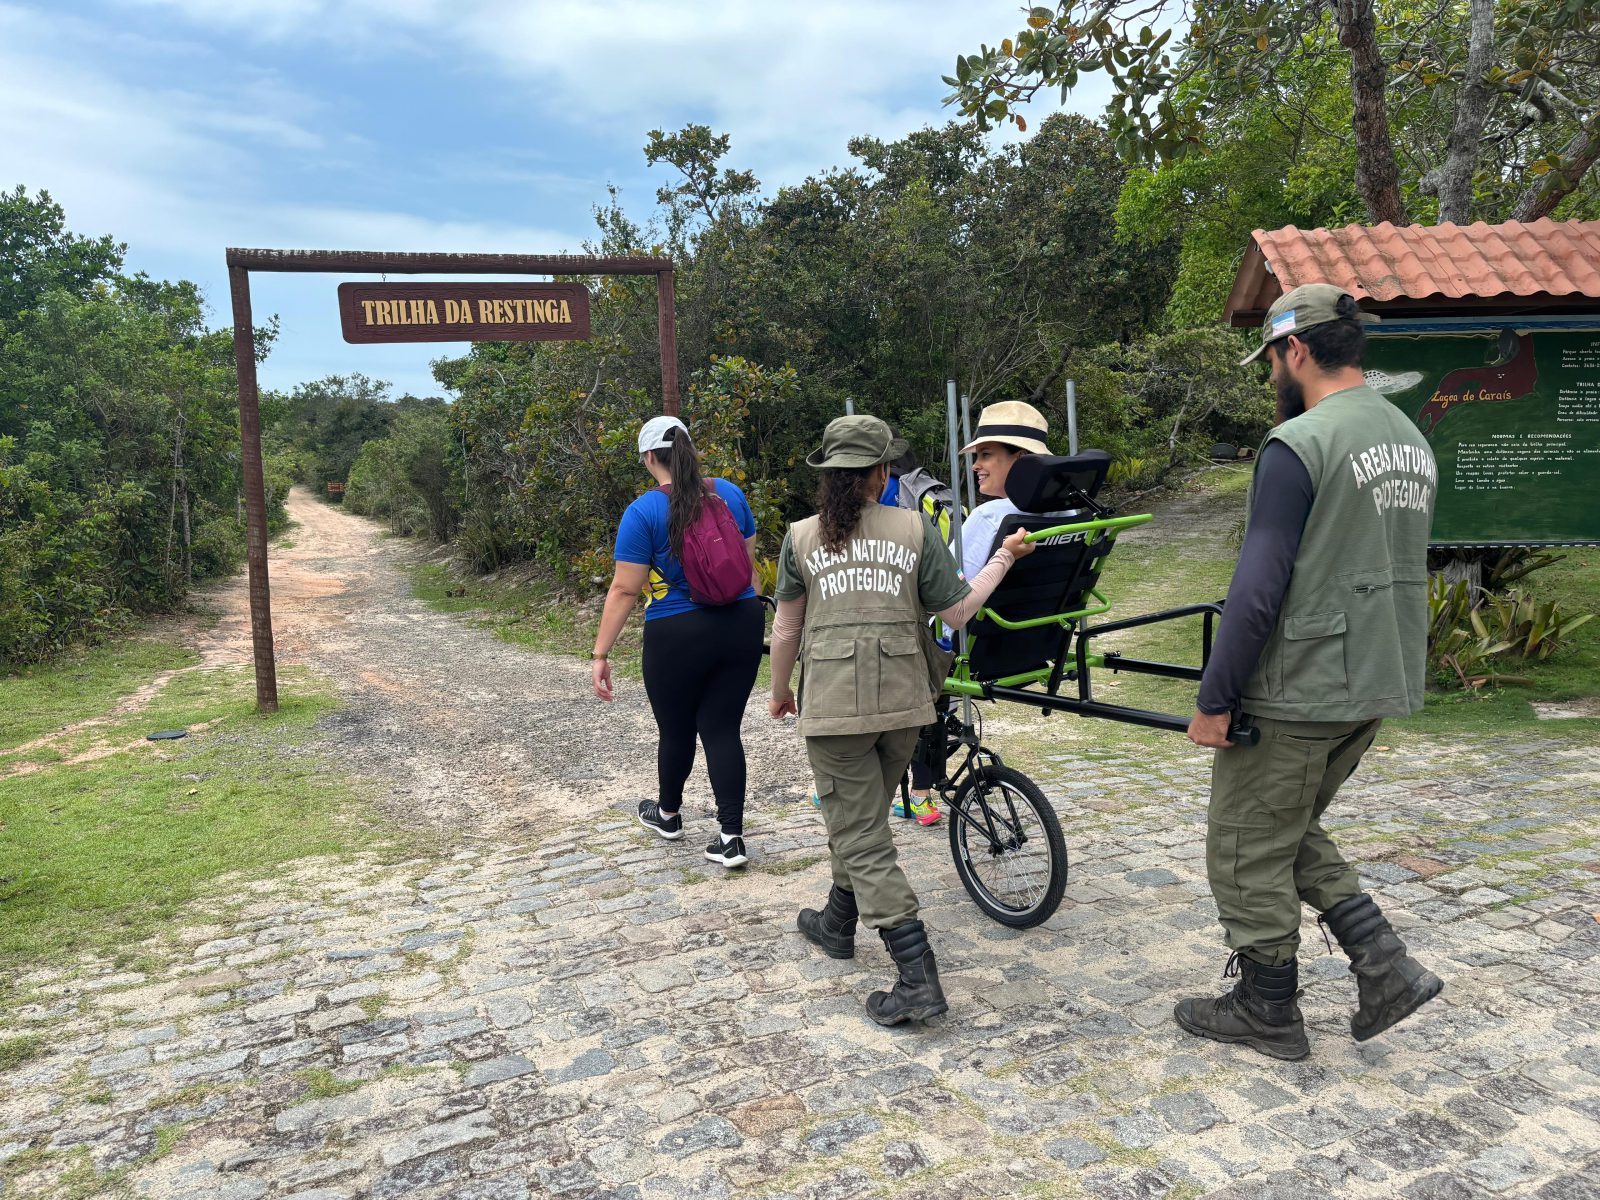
[226,246,678,712]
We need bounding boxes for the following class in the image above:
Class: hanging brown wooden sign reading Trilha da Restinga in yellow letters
[339,283,589,342]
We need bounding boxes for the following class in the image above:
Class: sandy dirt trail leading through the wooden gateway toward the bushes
[225,490,810,835]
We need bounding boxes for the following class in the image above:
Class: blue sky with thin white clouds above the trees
[0,0,1104,395]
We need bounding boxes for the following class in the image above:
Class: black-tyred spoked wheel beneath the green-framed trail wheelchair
[947,765,1067,930]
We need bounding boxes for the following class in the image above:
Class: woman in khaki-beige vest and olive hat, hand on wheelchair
[768,416,1034,1026]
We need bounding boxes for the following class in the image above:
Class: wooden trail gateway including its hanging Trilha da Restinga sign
[227,248,678,712]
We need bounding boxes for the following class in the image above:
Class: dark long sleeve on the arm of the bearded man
[1198,442,1317,715]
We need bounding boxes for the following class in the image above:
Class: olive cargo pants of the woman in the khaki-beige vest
[805,728,922,930]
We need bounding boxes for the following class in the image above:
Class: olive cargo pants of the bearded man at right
[1205,717,1382,966]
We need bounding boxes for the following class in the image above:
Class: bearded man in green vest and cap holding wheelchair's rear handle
[1174,283,1443,1059]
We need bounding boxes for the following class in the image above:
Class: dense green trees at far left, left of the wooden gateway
[0,189,272,662]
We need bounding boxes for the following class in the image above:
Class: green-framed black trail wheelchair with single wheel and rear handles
[901,450,1259,928]
